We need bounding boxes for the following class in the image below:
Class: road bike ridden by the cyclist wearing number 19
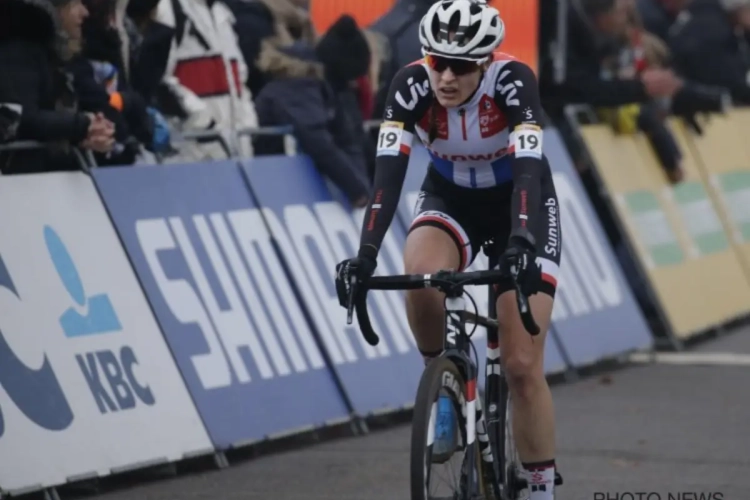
[347,270,562,500]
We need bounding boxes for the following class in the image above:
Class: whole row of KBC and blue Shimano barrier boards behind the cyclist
[0,129,651,493]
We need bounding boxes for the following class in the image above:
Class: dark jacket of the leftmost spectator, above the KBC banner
[0,0,90,174]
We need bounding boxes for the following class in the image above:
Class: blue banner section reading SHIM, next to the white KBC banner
[95,161,349,449]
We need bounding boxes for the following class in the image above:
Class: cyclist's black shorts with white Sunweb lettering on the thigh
[409,167,562,297]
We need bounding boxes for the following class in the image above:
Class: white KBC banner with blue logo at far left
[0,173,212,490]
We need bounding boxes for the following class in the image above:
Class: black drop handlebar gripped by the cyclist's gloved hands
[346,270,539,346]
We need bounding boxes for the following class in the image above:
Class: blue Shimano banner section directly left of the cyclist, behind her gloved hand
[244,156,424,415]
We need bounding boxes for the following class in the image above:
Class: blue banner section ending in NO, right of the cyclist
[544,128,653,366]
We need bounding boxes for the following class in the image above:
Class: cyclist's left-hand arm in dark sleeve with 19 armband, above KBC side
[359,65,432,259]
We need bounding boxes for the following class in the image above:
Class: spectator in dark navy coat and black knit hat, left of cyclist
[256,15,370,208]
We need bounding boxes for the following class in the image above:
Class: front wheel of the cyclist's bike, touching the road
[411,358,484,500]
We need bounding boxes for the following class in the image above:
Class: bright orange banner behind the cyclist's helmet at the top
[310,0,539,71]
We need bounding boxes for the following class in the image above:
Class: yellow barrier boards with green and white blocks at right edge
[579,119,750,340]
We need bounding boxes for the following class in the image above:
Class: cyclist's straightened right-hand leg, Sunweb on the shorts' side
[497,175,562,500]
